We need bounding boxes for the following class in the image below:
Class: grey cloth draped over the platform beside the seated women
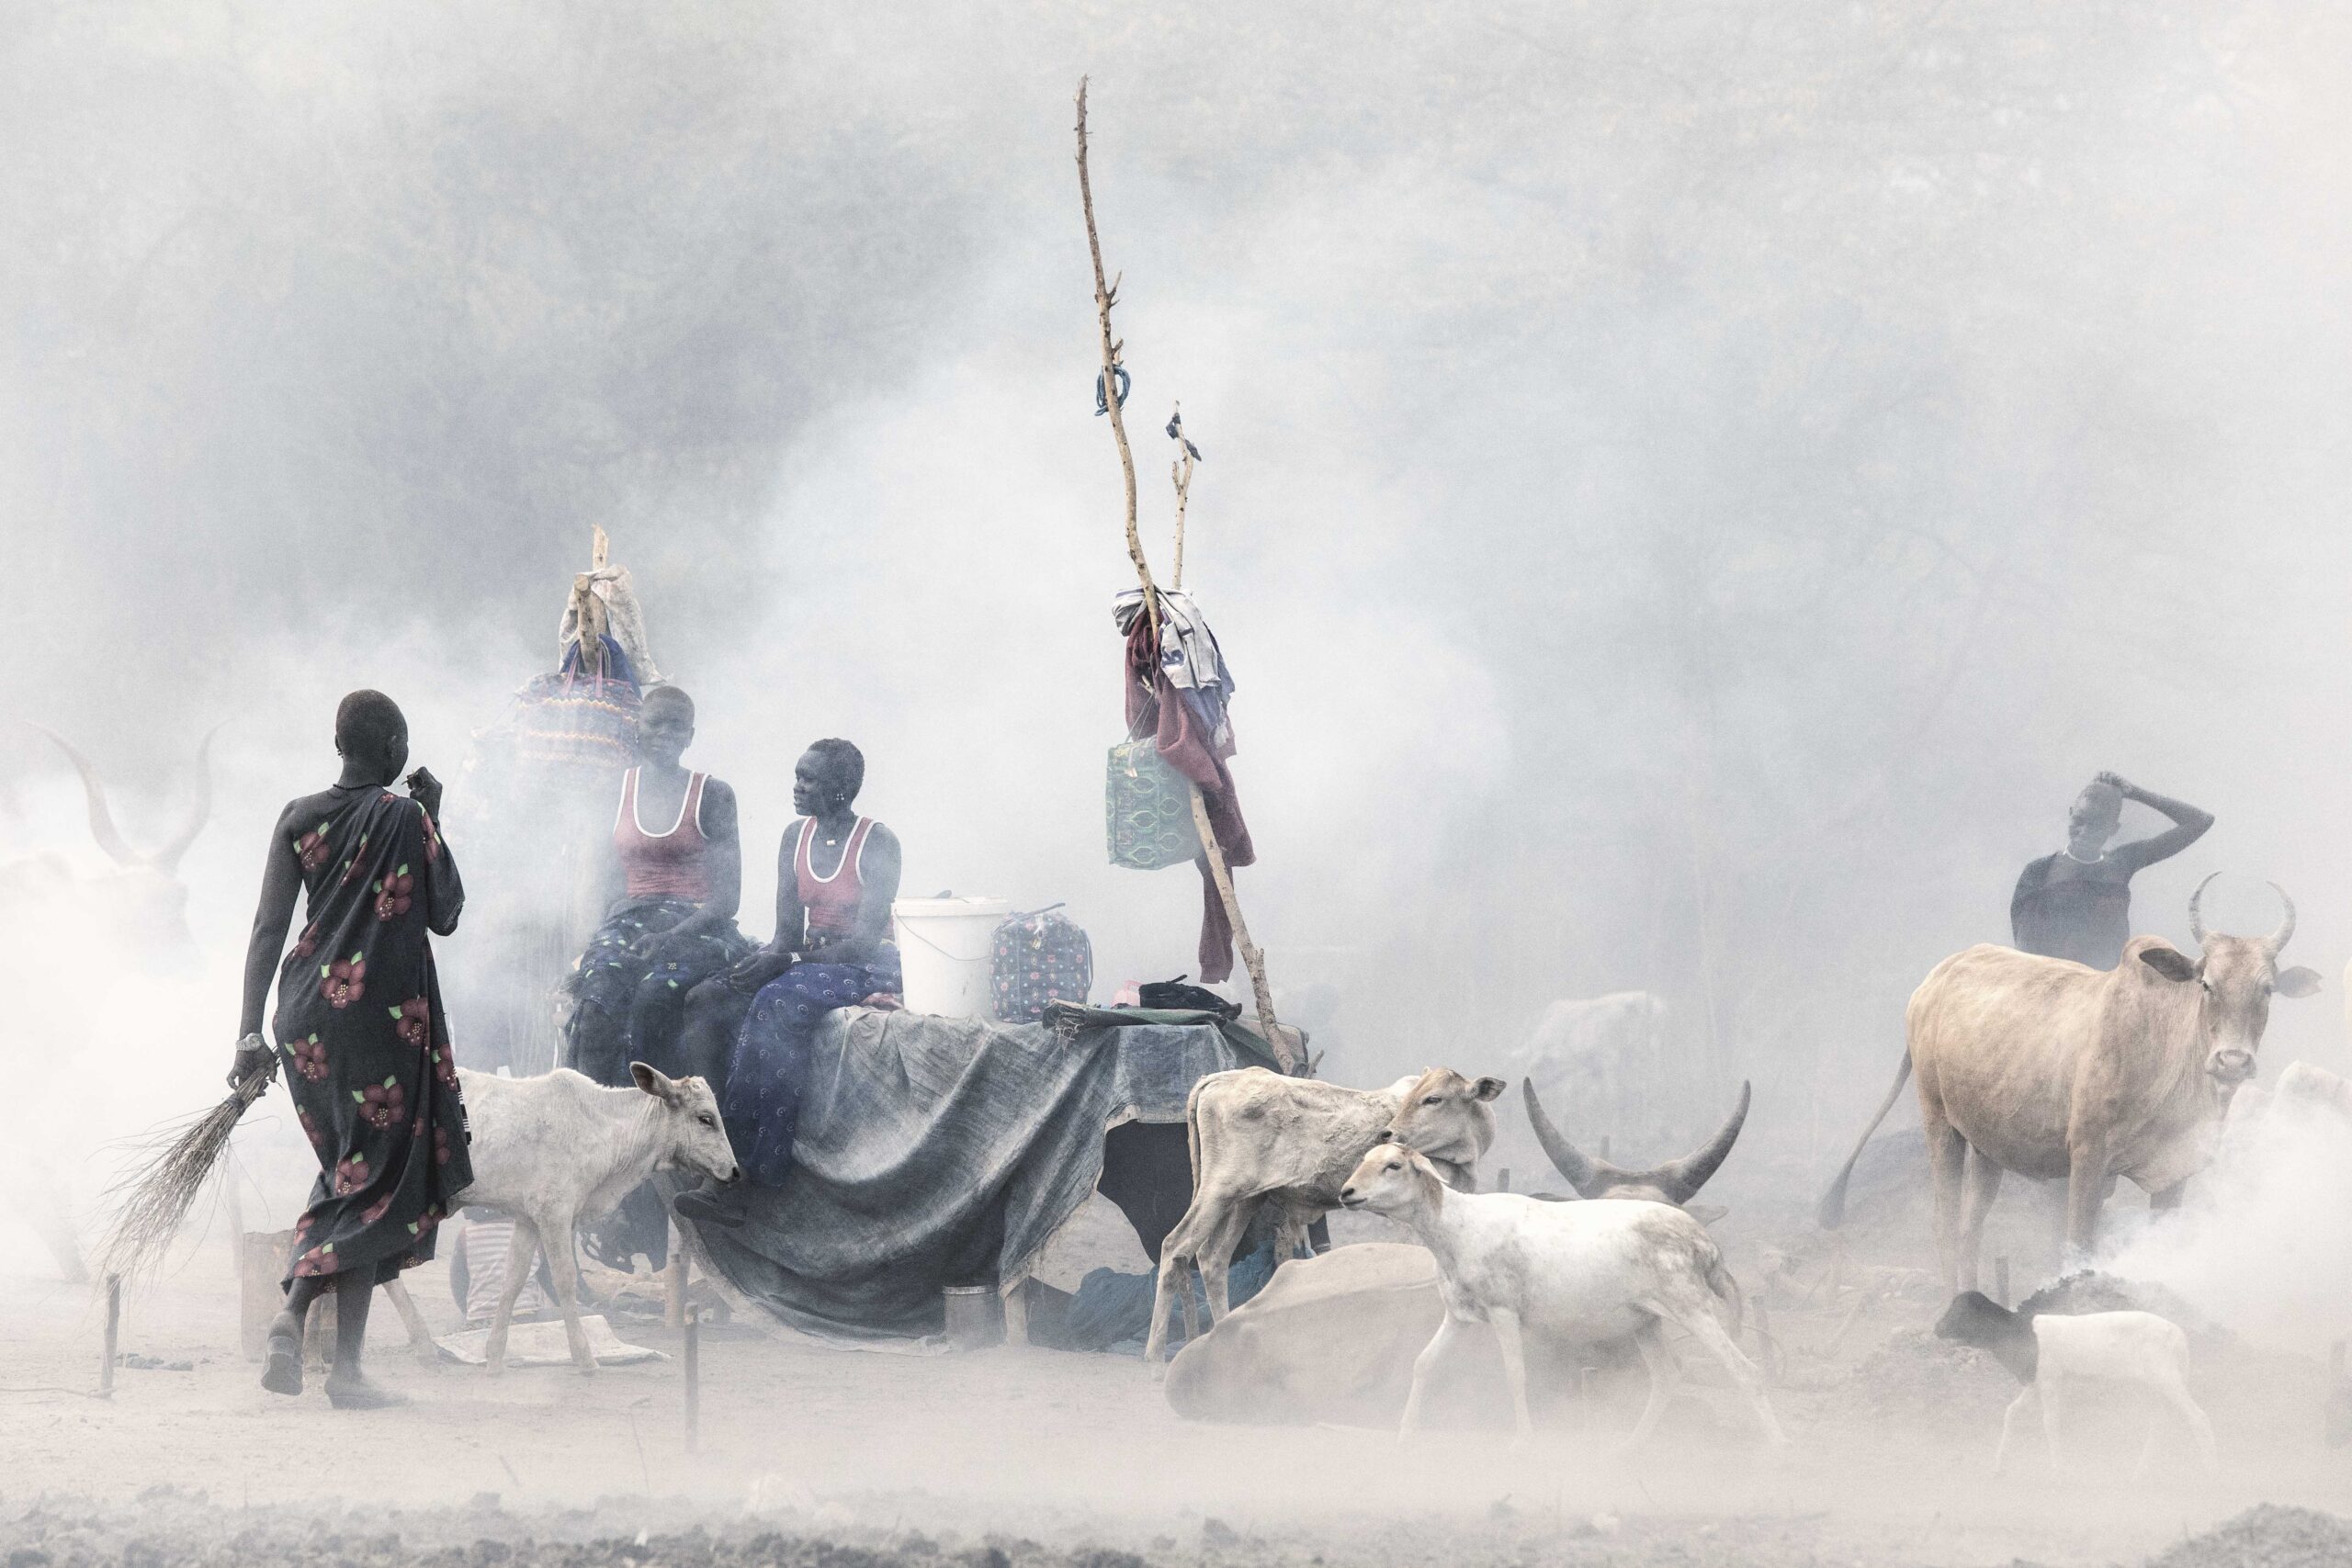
[696,1004,1275,1337]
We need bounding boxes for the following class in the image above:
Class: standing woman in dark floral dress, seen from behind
[231,691,473,1411]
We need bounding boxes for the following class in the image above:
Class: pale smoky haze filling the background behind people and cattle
[0,0,2352,1561]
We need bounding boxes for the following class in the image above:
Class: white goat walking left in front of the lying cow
[1340,1145,1788,1446]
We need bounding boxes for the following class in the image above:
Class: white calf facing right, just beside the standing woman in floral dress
[457,1063,736,1373]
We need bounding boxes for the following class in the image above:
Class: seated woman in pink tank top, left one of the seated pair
[564,686,751,1086]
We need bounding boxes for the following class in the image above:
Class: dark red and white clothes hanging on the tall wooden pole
[1113,590,1259,985]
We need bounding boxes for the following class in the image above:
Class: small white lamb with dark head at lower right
[1936,1291,2221,1476]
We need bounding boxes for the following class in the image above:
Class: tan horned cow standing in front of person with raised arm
[1820,877,2319,1293]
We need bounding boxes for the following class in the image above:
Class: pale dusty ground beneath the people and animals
[0,1189,2352,1568]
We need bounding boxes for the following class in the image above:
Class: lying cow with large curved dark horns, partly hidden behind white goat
[1167,1084,1750,1425]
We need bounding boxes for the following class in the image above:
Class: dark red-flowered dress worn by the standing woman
[273,787,473,1283]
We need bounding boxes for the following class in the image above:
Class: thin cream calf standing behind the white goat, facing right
[1143,1067,1503,1363]
